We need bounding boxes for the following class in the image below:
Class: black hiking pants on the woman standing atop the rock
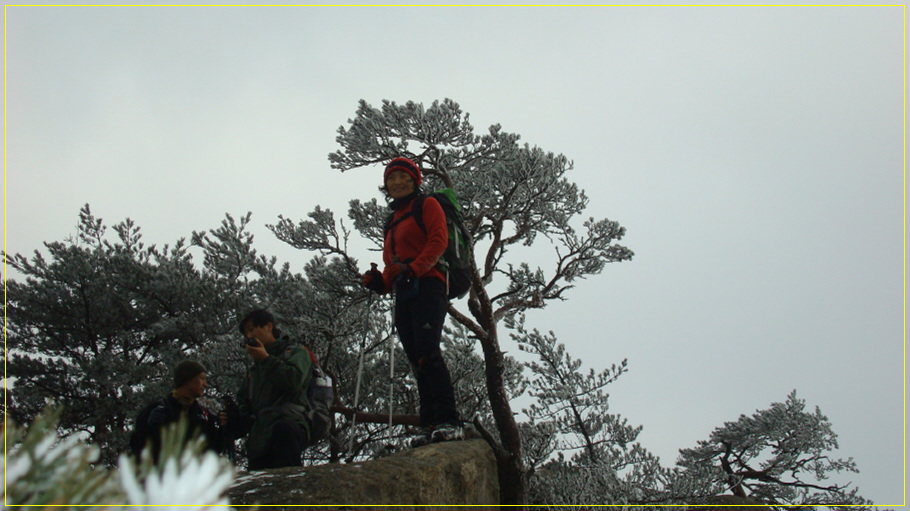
[395,277,461,427]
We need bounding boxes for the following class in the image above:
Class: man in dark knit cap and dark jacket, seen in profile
[130,360,225,463]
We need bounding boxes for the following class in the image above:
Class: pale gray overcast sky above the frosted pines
[5,6,905,505]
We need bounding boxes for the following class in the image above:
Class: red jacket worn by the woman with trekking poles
[382,197,449,289]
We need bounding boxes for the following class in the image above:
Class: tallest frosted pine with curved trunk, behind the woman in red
[273,99,632,504]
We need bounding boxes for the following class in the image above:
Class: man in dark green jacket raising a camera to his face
[222,309,312,470]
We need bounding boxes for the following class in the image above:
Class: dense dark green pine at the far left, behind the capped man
[4,205,216,465]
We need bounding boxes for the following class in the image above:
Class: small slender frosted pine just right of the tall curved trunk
[512,317,668,506]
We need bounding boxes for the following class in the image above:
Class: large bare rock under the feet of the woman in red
[229,440,499,511]
